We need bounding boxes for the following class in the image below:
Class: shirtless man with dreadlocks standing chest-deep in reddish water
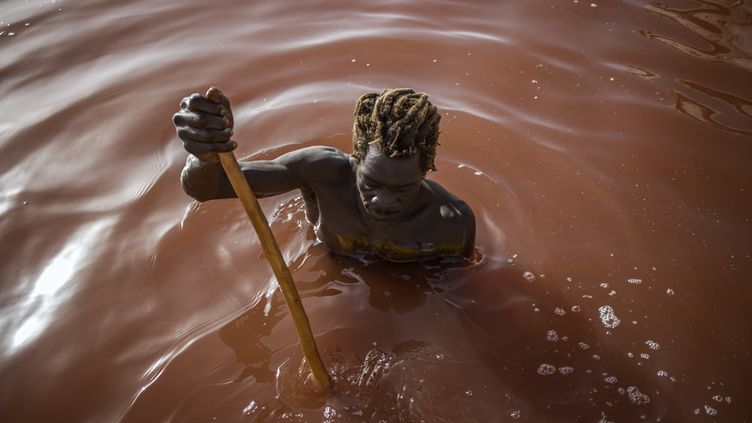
[173,88,475,261]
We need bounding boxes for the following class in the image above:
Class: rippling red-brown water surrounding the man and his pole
[0,0,752,422]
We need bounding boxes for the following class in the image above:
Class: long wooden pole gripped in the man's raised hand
[206,87,331,389]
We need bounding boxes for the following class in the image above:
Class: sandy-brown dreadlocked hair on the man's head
[352,88,441,173]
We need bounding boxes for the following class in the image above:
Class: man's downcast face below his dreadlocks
[355,144,424,220]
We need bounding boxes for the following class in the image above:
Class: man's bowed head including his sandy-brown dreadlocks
[353,88,441,220]
